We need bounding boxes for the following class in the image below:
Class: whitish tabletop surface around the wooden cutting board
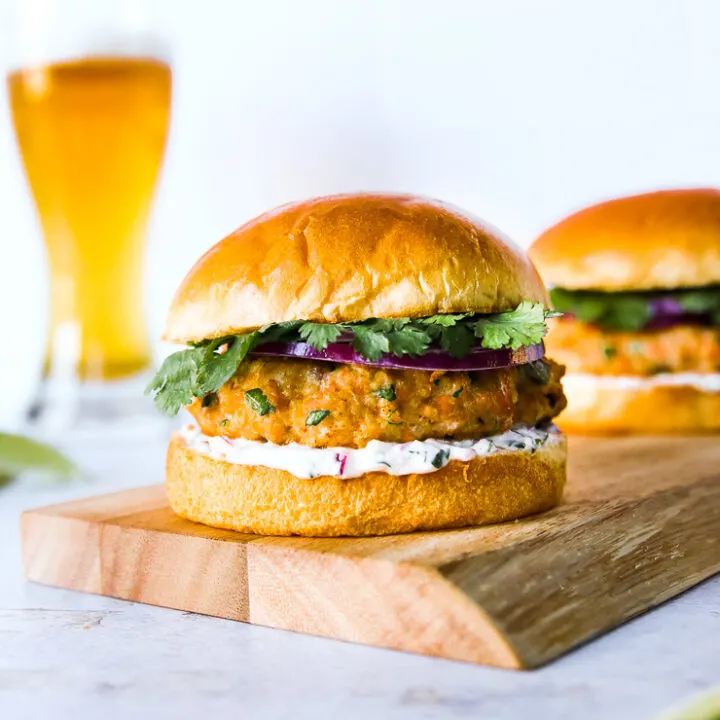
[0,435,720,720]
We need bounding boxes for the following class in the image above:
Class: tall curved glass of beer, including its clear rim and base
[7,0,171,426]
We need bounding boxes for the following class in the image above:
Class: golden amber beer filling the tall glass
[8,57,171,380]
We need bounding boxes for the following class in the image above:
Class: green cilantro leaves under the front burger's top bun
[145,301,557,415]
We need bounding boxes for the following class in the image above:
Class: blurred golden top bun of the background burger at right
[530,189,720,291]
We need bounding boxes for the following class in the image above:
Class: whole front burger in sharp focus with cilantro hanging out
[148,194,566,536]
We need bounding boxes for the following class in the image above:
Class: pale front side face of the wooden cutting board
[21,496,522,669]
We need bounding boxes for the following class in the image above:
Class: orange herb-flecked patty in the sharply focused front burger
[188,357,566,447]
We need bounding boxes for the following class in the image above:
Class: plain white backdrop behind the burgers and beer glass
[0,0,720,423]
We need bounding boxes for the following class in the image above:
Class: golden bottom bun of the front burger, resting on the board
[166,434,567,537]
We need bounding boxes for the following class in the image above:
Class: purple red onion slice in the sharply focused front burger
[252,342,545,372]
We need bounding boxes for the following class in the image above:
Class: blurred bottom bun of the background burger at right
[556,373,720,435]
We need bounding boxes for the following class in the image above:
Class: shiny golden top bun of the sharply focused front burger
[165,194,547,343]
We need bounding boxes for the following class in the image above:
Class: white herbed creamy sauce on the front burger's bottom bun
[180,425,560,479]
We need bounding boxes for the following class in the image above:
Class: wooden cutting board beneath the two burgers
[22,437,720,668]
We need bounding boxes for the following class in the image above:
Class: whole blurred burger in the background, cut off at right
[530,189,720,434]
